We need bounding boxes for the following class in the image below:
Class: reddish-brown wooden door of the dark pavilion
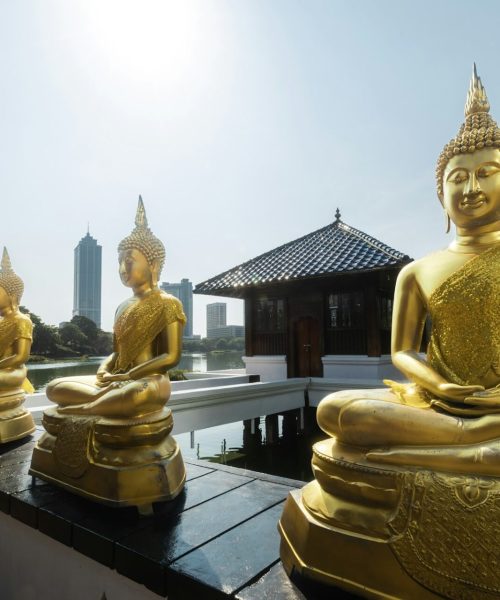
[294,317,323,377]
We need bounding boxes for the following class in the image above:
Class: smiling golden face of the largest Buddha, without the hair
[443,148,500,229]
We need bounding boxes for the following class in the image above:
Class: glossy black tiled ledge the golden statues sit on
[0,429,349,600]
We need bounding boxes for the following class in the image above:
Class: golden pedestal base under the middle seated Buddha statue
[30,408,186,512]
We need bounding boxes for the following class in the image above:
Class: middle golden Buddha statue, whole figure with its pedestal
[30,196,186,512]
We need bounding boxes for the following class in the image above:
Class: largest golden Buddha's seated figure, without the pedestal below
[317,67,500,475]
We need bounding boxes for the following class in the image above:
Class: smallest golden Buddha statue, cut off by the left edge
[0,248,35,444]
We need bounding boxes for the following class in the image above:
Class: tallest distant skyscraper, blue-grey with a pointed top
[73,231,102,327]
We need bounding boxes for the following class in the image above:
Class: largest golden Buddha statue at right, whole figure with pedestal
[280,66,500,599]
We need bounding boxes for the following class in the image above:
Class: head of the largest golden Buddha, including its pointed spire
[436,65,500,229]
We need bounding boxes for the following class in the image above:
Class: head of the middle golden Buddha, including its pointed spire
[118,196,165,288]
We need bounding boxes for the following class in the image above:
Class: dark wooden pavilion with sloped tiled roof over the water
[194,209,411,380]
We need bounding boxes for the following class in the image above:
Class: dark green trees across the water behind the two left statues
[20,306,113,358]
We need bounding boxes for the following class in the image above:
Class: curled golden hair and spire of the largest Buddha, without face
[436,63,500,202]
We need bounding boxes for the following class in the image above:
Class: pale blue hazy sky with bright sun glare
[0,0,500,335]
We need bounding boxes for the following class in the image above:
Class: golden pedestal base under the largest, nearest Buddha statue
[279,439,500,600]
